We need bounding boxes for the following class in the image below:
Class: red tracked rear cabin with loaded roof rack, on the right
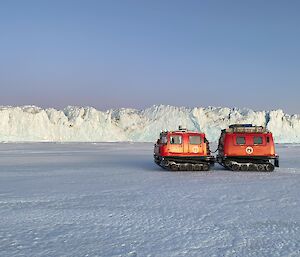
[217,124,279,171]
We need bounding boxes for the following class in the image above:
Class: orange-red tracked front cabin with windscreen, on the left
[154,126,215,171]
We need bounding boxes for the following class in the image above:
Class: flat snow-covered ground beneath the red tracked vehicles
[0,143,300,257]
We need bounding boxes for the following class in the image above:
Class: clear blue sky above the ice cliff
[0,0,300,113]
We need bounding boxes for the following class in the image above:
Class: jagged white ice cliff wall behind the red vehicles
[0,105,300,143]
